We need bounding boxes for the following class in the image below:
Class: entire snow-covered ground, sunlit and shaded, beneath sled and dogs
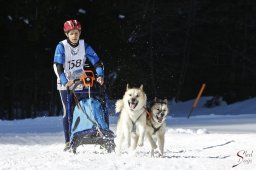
[0,98,256,170]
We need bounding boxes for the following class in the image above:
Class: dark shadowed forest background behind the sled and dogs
[0,0,256,120]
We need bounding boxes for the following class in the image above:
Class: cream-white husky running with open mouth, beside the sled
[115,84,147,155]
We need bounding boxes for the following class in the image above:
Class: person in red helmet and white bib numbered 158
[54,20,104,151]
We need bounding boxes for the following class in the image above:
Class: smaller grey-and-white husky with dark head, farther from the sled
[145,98,169,157]
